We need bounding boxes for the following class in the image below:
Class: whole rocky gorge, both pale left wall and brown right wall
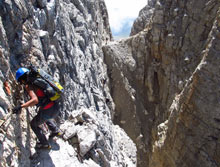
[0,0,220,167]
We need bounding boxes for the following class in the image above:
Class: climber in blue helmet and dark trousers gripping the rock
[12,67,61,149]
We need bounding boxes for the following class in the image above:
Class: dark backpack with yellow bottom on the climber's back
[28,66,64,101]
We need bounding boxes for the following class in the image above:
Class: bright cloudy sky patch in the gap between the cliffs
[105,0,148,40]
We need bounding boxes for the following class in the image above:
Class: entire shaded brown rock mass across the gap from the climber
[103,0,220,167]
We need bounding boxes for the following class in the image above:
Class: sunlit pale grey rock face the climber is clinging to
[0,0,136,167]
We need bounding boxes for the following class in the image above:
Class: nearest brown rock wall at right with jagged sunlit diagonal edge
[150,11,220,167]
